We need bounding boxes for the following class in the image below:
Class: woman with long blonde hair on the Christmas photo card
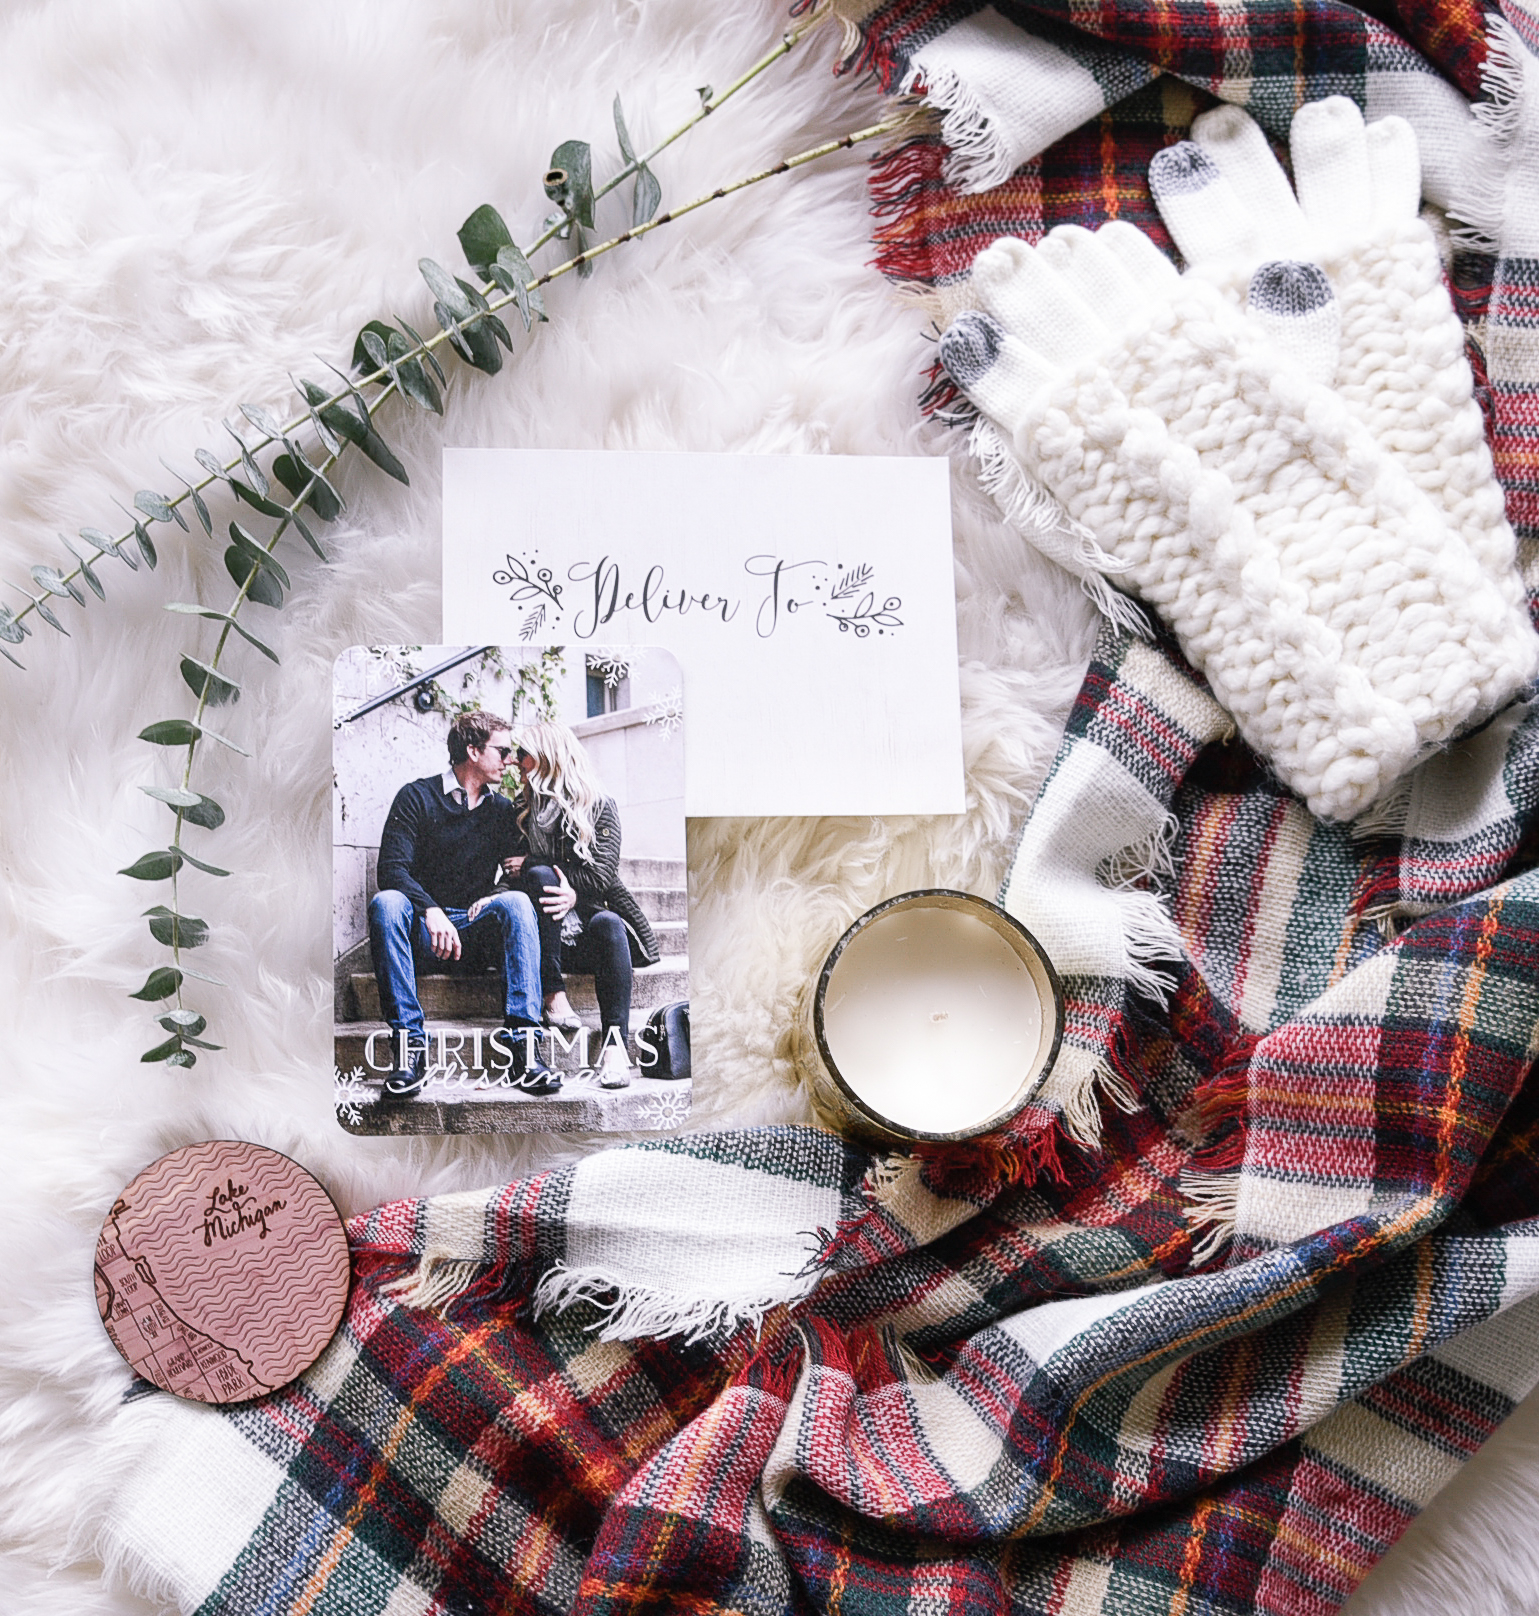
[504,721,660,1088]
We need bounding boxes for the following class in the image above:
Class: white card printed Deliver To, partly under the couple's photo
[443,449,963,814]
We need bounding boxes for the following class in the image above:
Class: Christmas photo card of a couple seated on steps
[333,646,689,1133]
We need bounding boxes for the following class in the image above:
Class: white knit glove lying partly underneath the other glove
[1149,95,1524,611]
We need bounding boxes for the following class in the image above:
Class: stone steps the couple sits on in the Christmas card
[335,858,690,1133]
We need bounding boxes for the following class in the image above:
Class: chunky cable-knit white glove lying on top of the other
[941,223,1539,819]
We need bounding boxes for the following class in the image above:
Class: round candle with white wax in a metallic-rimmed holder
[812,889,1062,1141]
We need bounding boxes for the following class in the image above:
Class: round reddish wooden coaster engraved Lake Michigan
[95,1139,348,1403]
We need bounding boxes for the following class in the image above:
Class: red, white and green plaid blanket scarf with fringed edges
[102,0,1539,1616]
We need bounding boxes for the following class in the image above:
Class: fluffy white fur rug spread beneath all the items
[0,0,1539,1616]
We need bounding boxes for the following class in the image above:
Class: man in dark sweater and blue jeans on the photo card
[369,708,561,1099]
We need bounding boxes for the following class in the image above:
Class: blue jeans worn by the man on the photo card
[369,892,542,1046]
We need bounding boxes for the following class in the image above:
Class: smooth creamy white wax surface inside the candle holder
[823,905,1044,1134]
